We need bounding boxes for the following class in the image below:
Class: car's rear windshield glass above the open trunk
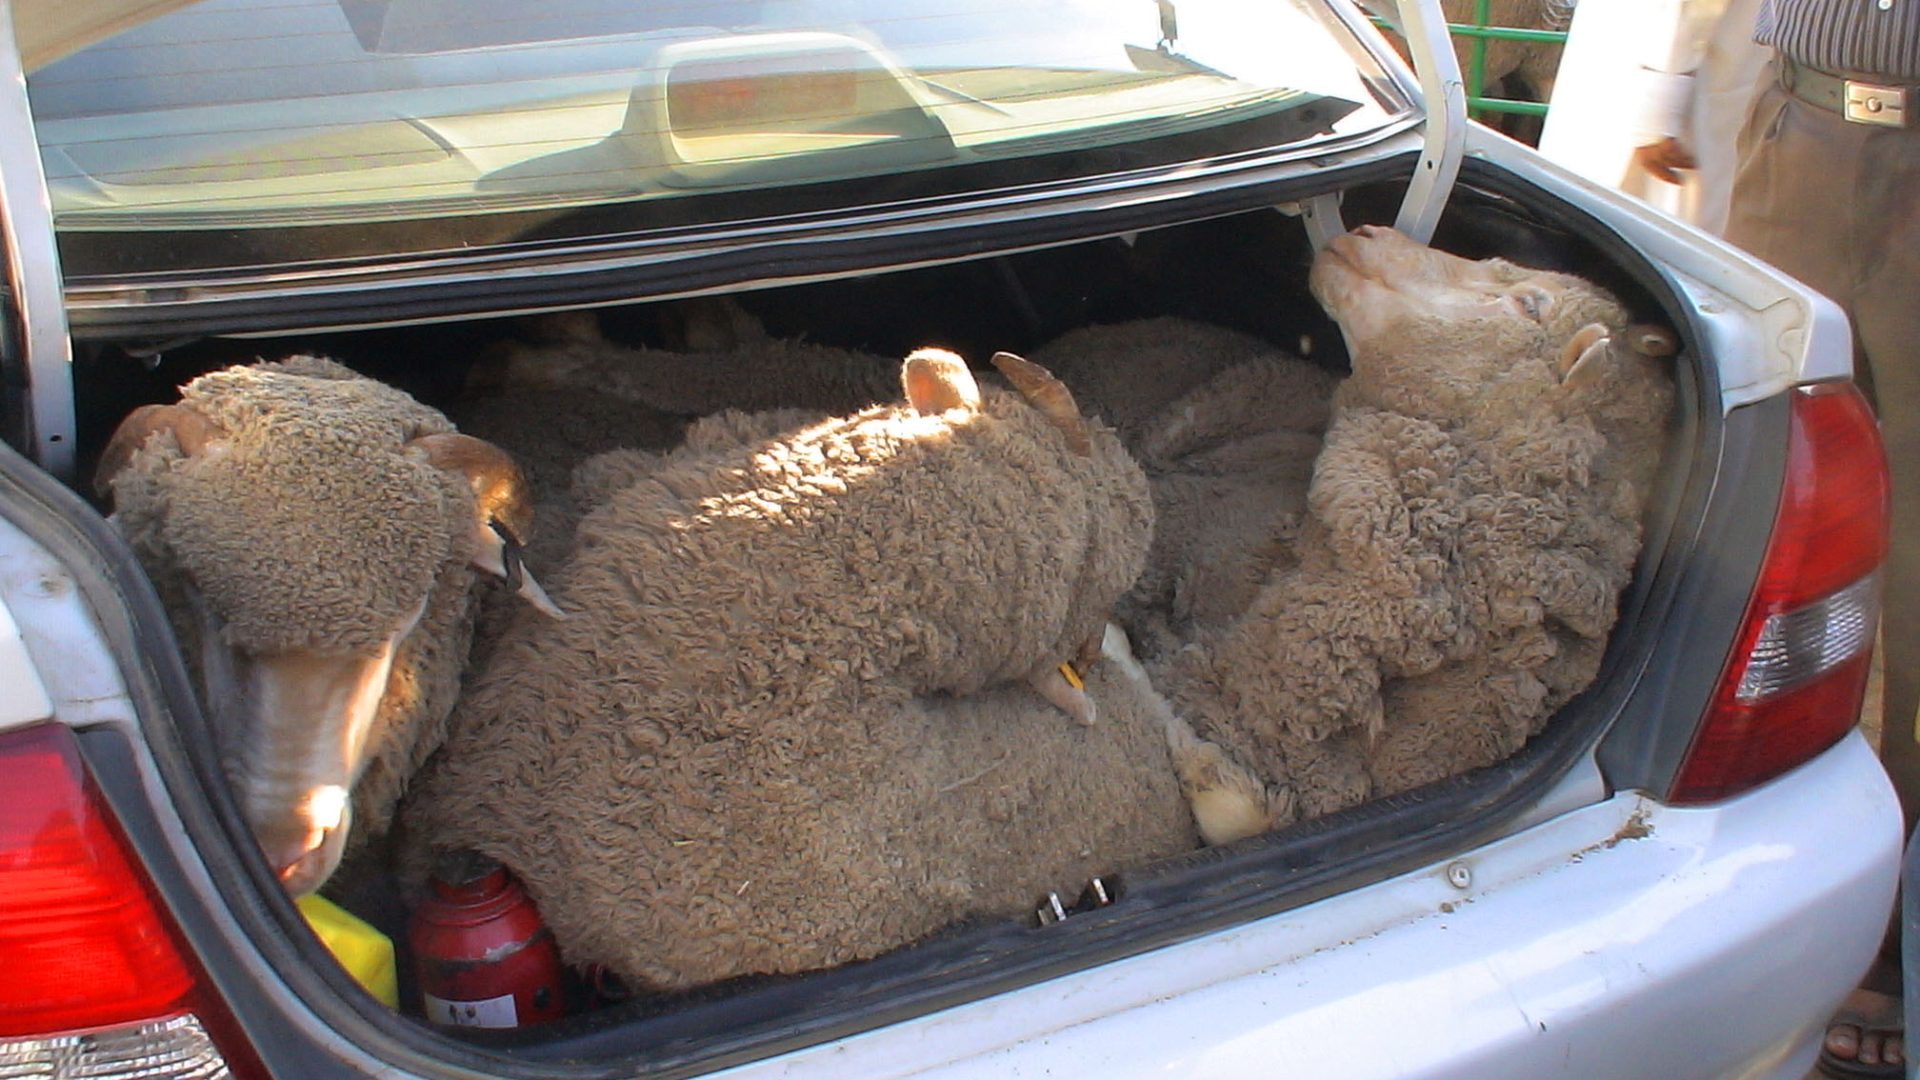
[29,0,1407,277]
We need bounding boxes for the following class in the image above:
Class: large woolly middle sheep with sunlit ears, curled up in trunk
[403,350,1196,992]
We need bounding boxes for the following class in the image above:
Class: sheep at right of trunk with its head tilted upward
[1154,225,1674,832]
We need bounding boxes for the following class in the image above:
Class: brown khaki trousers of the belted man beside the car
[1726,67,1920,830]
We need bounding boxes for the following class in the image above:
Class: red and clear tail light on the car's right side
[1668,382,1887,803]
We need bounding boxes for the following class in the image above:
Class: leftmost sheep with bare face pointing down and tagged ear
[96,357,559,896]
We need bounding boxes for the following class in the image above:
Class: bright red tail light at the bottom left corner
[0,723,257,1076]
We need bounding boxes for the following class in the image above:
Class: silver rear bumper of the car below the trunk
[733,734,1901,1080]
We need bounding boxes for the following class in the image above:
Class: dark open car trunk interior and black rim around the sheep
[41,163,1712,1074]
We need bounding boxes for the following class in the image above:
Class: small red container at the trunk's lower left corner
[407,853,564,1028]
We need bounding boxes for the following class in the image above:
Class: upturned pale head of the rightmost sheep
[1308,225,1672,423]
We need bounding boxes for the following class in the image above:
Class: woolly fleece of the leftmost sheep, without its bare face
[99,357,487,860]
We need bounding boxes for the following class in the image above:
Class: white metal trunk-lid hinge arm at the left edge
[0,0,75,480]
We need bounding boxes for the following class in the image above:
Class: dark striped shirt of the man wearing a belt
[1753,0,1920,83]
